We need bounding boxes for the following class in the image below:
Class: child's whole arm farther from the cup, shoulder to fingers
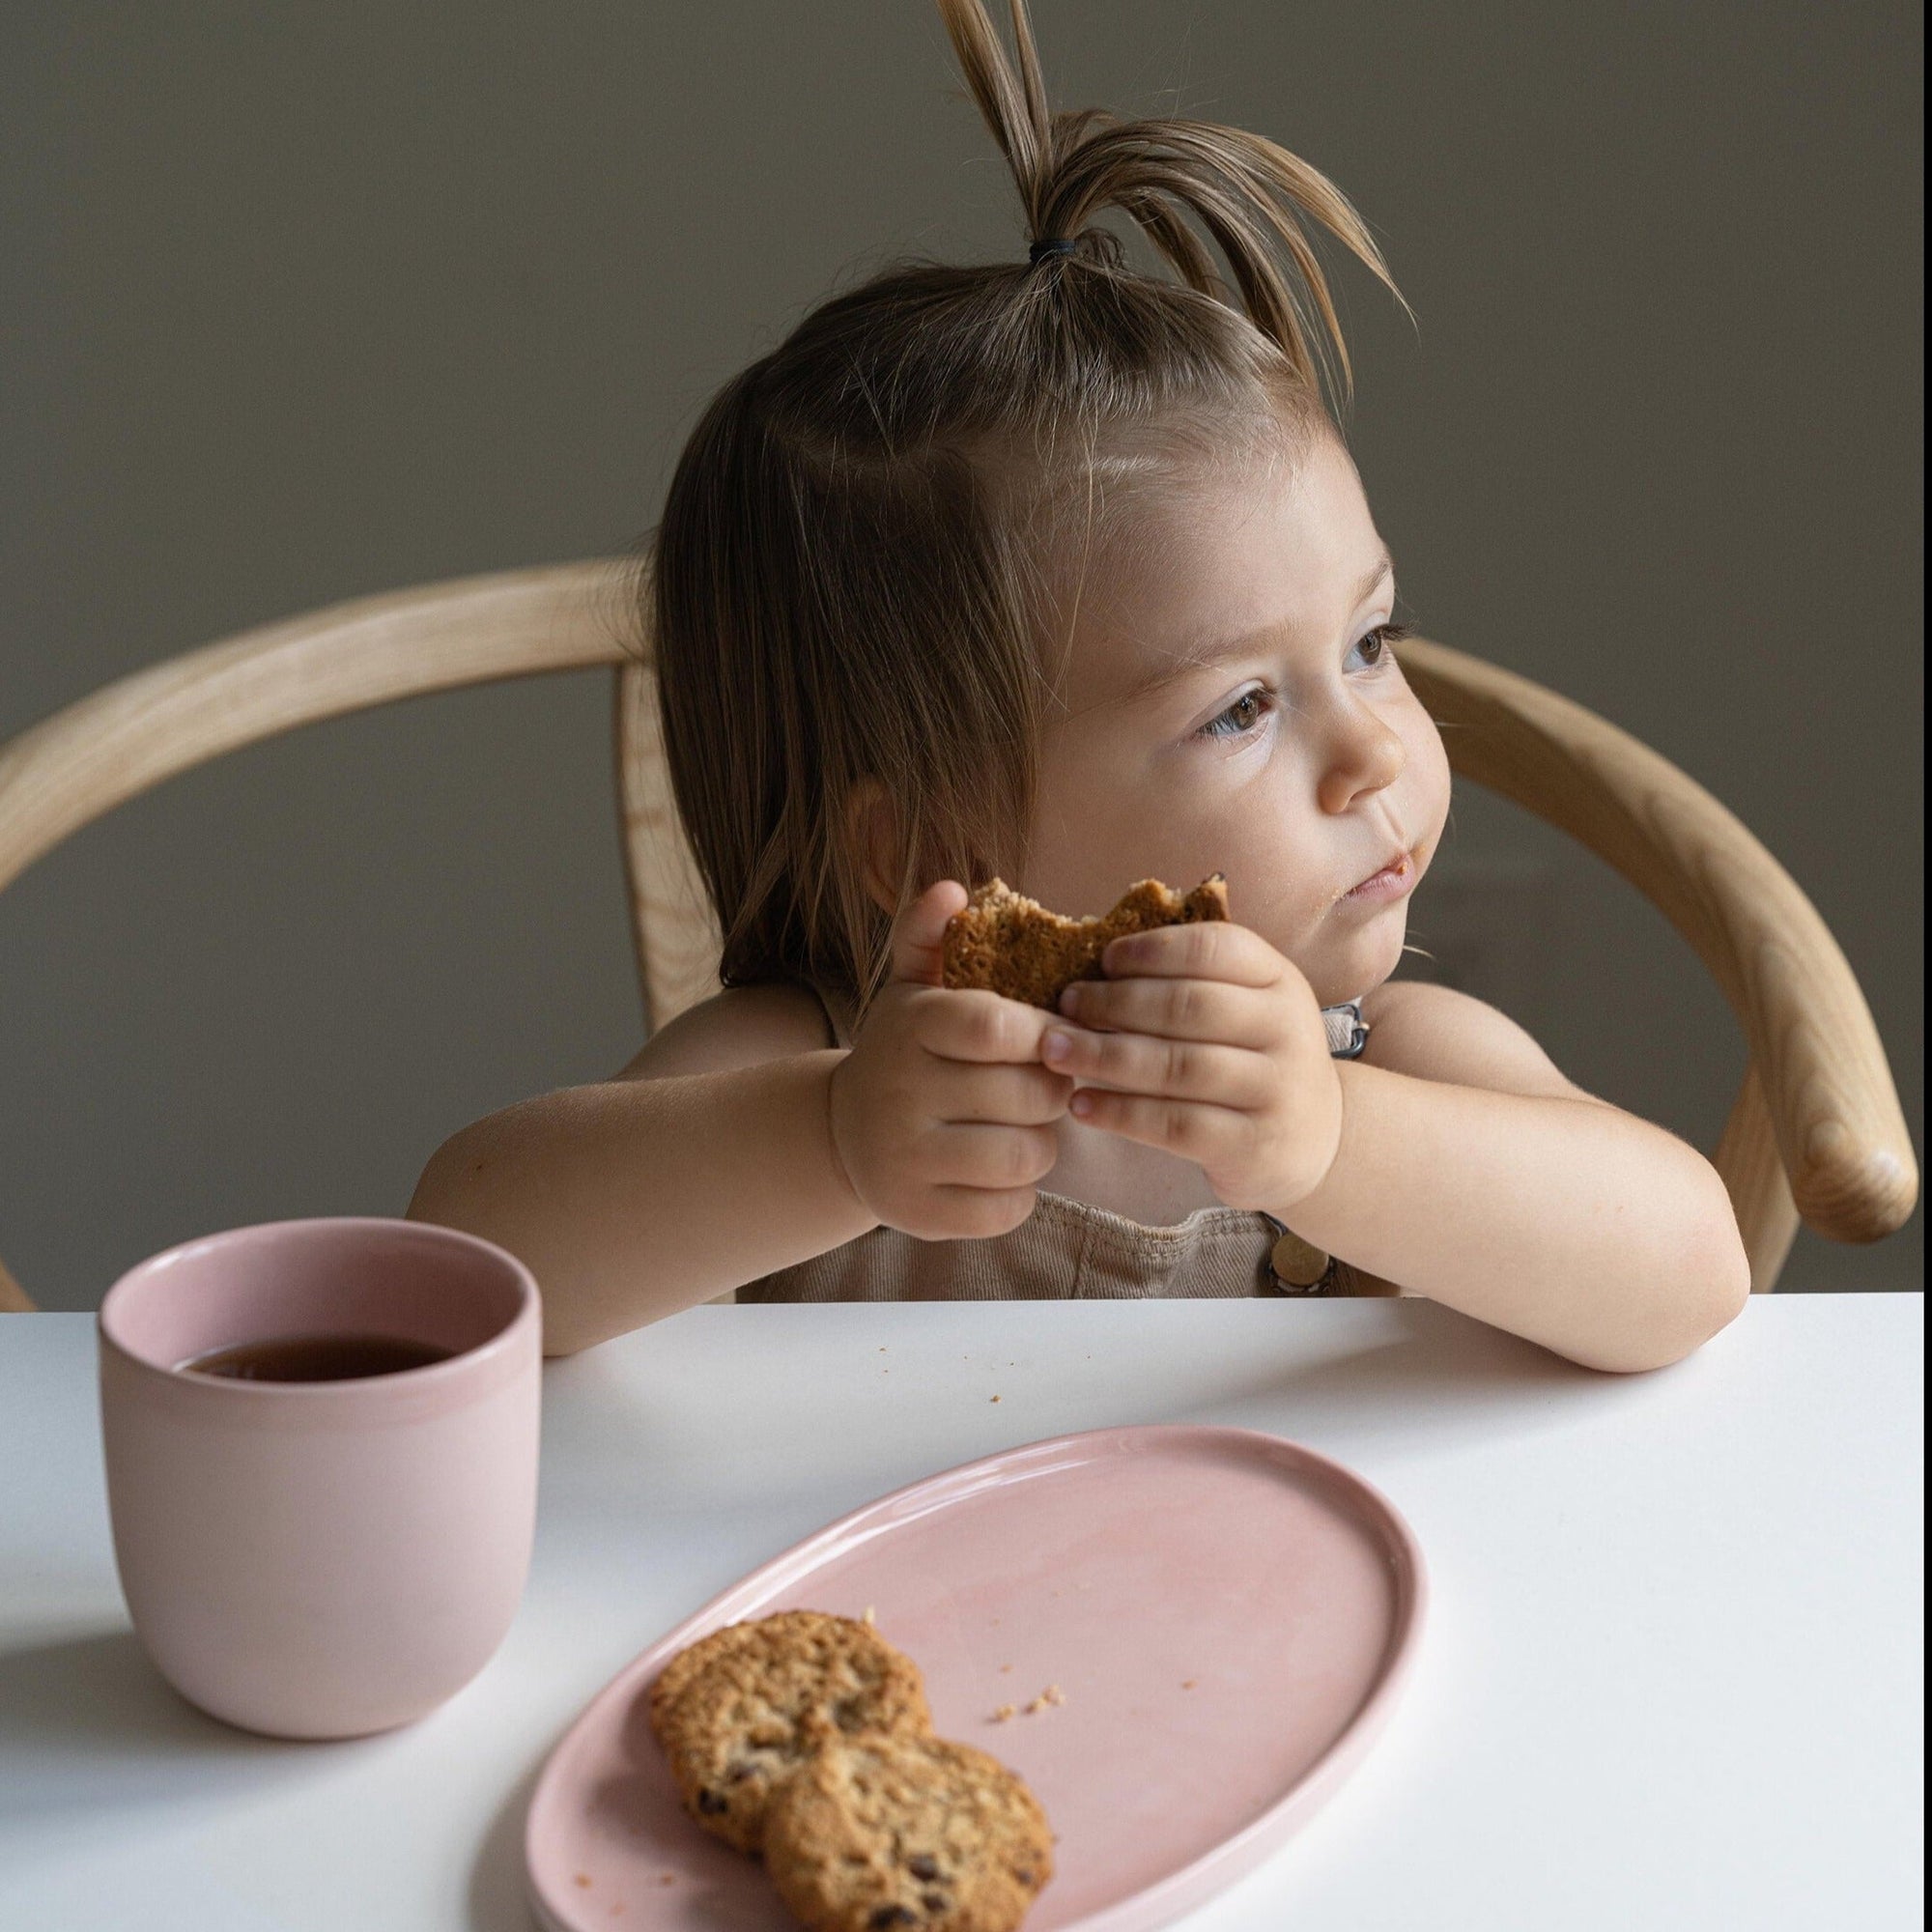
[1049,925,1750,1370]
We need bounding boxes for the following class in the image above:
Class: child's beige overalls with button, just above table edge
[738,995,1368,1302]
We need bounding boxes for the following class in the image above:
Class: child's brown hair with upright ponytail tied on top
[638,0,1401,1007]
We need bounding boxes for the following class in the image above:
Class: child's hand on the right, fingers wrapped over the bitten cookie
[1041,920,1343,1215]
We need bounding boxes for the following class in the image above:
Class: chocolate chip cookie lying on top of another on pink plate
[765,1735,1053,1932]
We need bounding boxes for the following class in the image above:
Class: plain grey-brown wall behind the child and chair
[0,0,1922,1308]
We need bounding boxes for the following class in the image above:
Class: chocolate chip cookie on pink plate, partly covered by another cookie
[649,1609,933,1853]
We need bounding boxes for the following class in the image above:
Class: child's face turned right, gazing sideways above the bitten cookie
[1016,433,1449,1005]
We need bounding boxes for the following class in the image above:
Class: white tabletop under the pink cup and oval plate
[0,1294,1924,1932]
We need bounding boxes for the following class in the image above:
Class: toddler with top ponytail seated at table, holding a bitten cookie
[410,0,1748,1370]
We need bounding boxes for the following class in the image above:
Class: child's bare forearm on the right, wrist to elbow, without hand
[1283,1061,1750,1370]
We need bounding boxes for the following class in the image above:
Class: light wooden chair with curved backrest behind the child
[0,558,1918,1310]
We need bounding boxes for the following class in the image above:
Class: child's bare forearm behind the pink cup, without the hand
[410,1051,877,1354]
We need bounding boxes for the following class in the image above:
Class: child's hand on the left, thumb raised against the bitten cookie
[831,879,1074,1240]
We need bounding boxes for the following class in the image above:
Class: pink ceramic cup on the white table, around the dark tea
[100,1219,541,1737]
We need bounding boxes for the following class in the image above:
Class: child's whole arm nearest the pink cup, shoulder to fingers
[408,885,1072,1354]
